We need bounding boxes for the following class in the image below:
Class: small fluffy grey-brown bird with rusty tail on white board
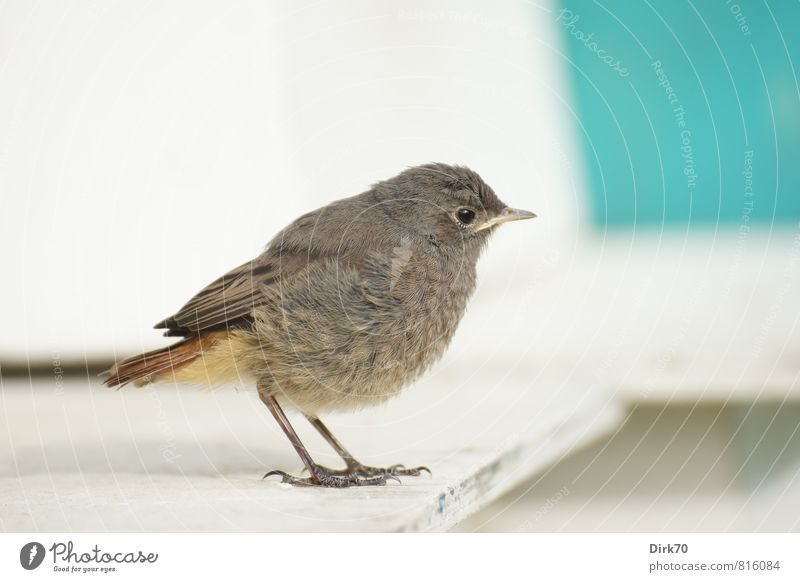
[102,163,536,488]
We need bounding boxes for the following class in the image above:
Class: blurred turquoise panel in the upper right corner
[553,0,800,227]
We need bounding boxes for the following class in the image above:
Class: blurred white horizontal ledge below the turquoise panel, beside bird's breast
[456,226,800,401]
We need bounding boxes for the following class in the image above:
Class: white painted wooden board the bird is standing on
[0,366,622,531]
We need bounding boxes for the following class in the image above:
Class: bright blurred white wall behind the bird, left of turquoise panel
[0,0,581,361]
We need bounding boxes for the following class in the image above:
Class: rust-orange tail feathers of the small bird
[100,336,207,387]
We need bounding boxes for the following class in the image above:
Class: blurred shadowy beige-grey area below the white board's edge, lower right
[456,406,800,536]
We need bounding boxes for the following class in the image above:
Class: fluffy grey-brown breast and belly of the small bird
[247,256,475,412]
